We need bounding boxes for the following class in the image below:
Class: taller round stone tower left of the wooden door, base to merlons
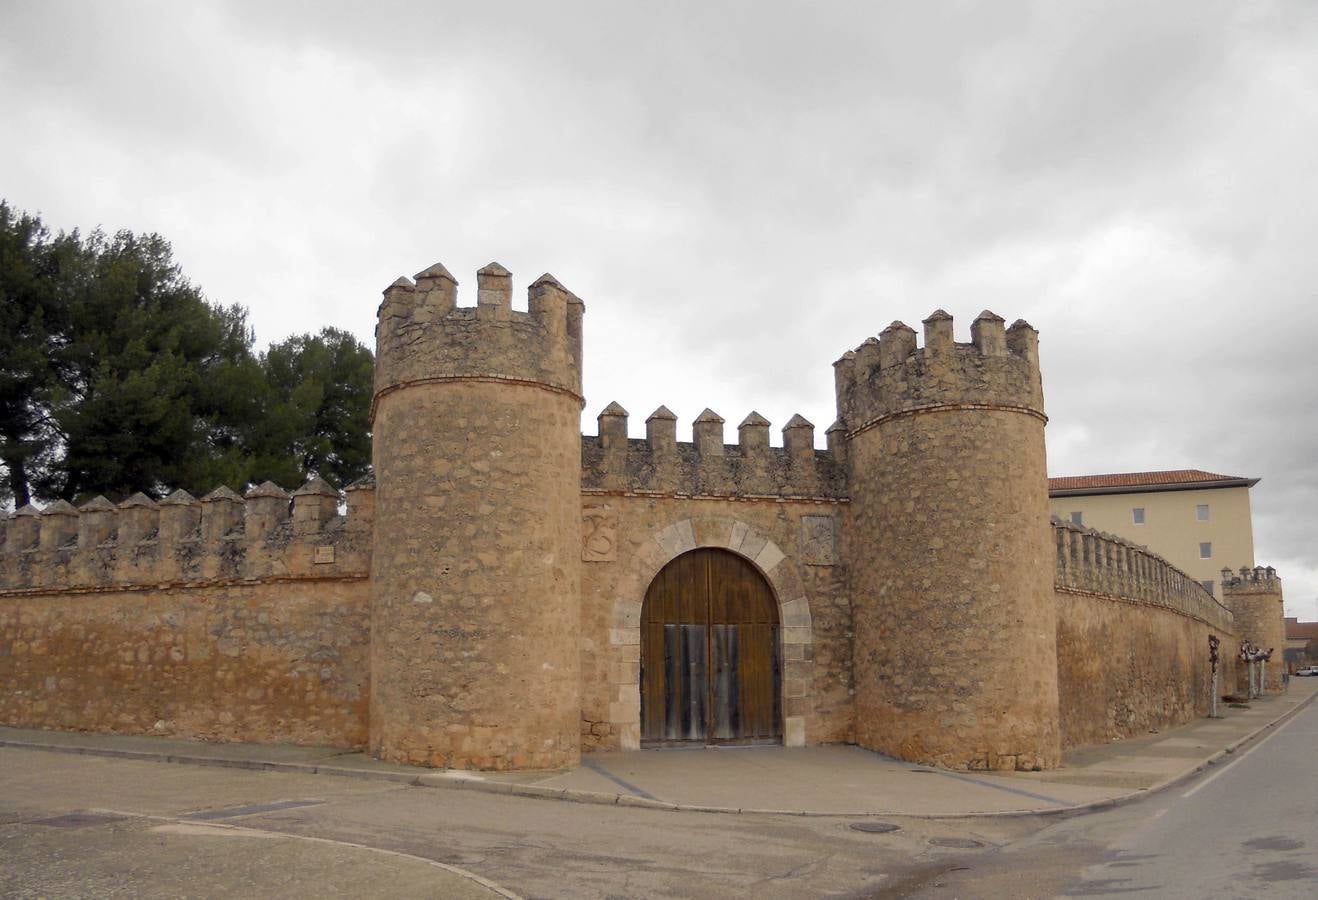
[370,262,584,770]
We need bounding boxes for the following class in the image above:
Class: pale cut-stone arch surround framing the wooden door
[609,515,815,750]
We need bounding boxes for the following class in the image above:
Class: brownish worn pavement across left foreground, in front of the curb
[0,748,1037,899]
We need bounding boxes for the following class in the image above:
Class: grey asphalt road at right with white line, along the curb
[901,705,1318,900]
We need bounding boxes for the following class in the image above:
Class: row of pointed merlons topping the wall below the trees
[0,478,374,592]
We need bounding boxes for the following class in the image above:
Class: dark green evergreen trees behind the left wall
[0,202,373,505]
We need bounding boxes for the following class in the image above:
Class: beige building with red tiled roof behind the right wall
[1048,469,1259,600]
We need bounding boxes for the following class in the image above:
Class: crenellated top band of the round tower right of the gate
[833,310,1044,434]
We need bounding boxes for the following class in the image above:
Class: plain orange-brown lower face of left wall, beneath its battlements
[0,580,370,746]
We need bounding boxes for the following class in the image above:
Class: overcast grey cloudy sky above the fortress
[0,0,1318,618]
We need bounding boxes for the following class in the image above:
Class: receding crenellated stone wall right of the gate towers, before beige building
[1053,519,1239,748]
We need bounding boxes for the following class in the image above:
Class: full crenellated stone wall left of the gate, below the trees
[0,478,373,746]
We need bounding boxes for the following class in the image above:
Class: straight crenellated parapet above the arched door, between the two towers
[581,403,846,499]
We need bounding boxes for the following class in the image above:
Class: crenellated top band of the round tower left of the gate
[376,262,585,401]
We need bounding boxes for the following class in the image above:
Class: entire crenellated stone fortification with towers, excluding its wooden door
[0,264,1284,770]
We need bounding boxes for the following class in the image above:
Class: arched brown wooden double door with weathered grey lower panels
[641,548,783,745]
